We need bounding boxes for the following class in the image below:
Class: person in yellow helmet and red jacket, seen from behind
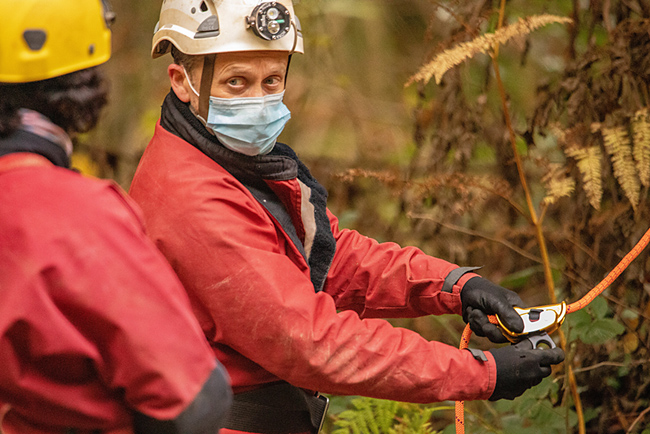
[0,0,232,434]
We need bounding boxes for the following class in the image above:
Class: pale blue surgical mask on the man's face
[185,66,291,156]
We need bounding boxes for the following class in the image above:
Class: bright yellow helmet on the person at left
[0,0,115,83]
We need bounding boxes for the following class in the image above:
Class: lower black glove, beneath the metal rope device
[490,339,564,401]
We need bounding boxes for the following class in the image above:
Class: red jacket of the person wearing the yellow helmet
[0,153,216,434]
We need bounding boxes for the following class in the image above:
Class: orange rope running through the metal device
[456,229,650,434]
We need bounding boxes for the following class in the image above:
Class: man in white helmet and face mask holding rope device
[131,0,564,433]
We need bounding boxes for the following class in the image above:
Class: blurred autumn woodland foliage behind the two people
[82,0,650,434]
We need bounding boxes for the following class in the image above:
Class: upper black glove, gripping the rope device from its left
[460,276,524,344]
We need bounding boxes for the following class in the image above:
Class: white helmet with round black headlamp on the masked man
[152,0,303,58]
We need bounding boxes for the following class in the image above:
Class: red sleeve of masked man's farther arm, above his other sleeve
[324,213,477,318]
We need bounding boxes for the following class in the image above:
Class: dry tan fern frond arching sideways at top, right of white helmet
[406,14,573,86]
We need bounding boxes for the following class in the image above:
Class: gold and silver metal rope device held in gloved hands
[497,301,567,348]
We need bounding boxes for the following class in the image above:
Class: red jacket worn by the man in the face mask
[130,124,496,403]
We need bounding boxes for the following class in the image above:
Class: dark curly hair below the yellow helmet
[0,67,108,137]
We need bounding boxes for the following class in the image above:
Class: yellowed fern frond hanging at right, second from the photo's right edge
[601,126,641,210]
